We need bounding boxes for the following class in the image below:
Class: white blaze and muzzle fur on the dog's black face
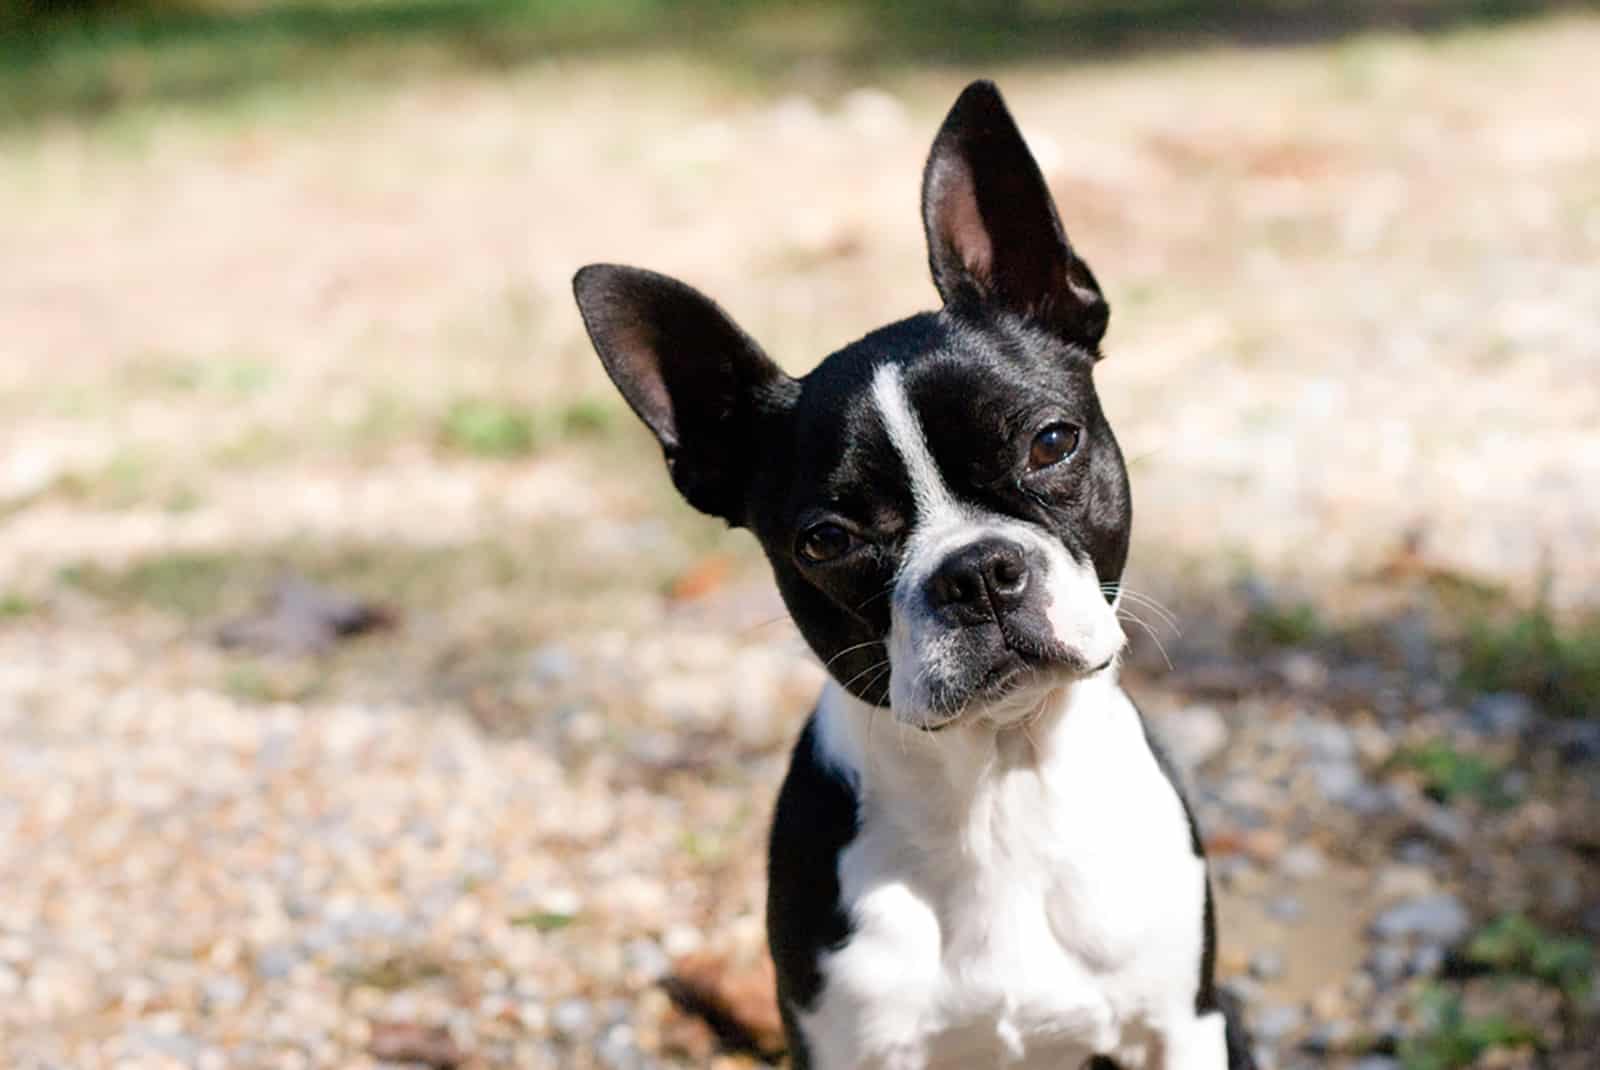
[872,365,1126,728]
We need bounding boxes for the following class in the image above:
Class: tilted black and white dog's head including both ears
[574,83,1131,728]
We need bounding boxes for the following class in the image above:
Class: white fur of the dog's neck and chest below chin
[800,672,1227,1070]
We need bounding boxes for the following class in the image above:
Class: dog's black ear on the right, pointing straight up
[922,82,1110,350]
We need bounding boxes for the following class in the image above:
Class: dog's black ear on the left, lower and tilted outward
[573,264,795,525]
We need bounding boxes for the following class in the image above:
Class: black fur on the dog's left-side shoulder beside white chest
[766,703,859,1067]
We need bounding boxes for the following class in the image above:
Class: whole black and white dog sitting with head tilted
[574,82,1250,1070]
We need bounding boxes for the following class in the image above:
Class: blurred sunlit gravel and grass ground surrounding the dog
[0,0,1600,1070]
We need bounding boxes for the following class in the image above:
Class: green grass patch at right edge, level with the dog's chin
[1461,598,1600,717]
